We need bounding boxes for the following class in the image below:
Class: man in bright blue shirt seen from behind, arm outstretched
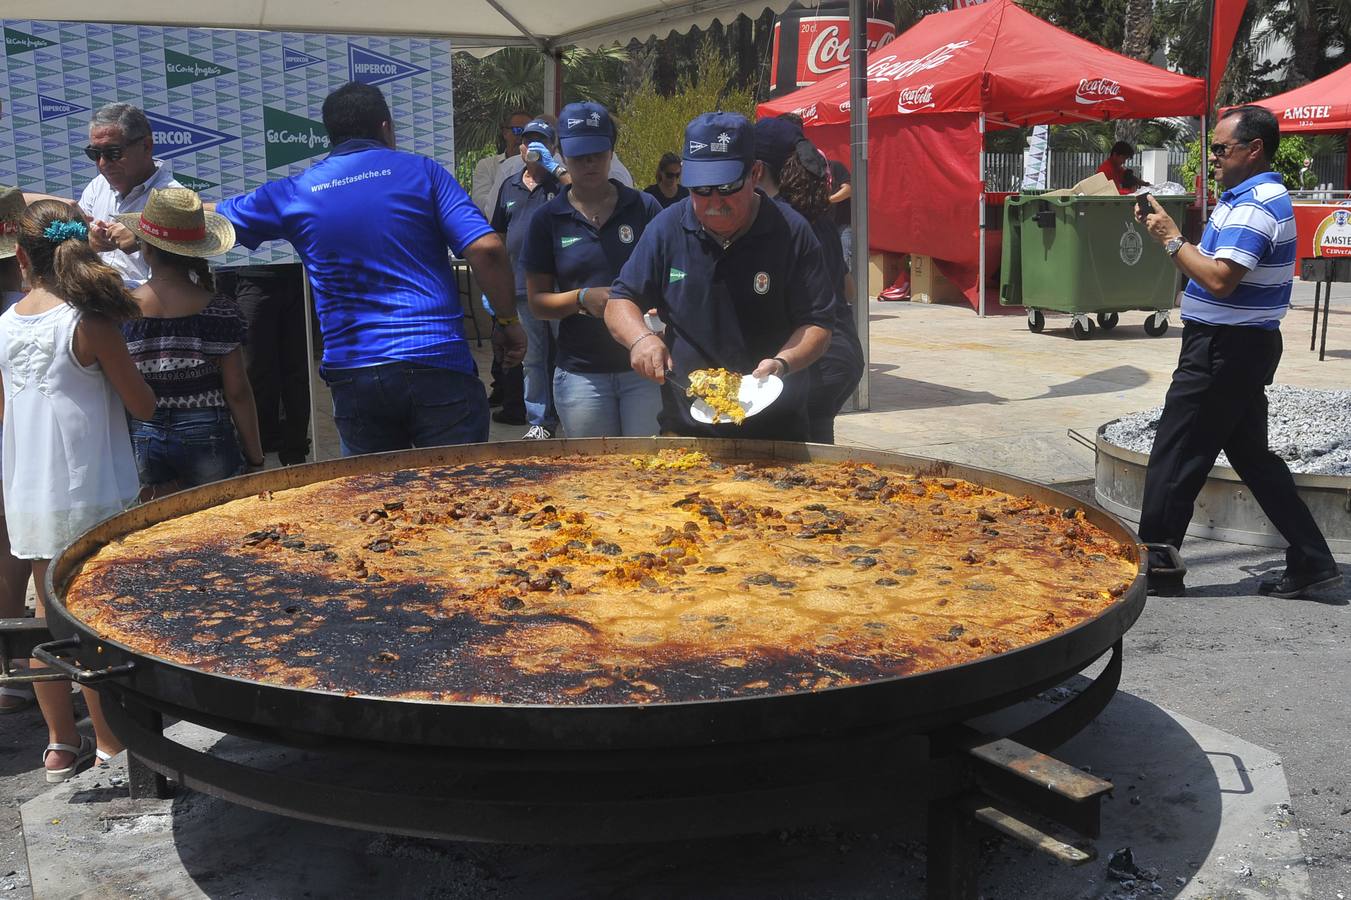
[216,82,526,455]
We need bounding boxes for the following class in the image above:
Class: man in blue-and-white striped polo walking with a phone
[1140,107,1342,597]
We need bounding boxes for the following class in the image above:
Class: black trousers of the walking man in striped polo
[1140,322,1336,572]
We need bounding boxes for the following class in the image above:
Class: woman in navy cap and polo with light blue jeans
[521,103,662,438]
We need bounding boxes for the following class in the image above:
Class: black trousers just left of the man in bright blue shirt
[218,265,309,465]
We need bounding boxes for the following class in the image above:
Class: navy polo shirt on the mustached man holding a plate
[611,195,835,441]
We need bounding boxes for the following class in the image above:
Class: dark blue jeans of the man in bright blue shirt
[319,362,488,457]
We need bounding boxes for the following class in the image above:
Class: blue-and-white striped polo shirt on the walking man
[1182,172,1296,328]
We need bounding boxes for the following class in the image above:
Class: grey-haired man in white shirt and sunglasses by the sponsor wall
[80,103,182,291]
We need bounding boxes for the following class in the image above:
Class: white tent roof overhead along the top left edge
[23,0,788,50]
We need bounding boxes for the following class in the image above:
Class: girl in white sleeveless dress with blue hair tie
[0,200,155,782]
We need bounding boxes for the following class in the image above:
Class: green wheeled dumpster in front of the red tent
[1000,192,1192,338]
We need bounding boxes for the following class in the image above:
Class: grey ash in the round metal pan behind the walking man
[1102,384,1351,474]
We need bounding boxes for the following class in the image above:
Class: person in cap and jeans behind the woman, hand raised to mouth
[493,119,567,441]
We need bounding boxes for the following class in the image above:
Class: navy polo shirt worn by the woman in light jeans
[521,180,662,373]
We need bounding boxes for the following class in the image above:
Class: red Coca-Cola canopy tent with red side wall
[759,0,1205,314]
